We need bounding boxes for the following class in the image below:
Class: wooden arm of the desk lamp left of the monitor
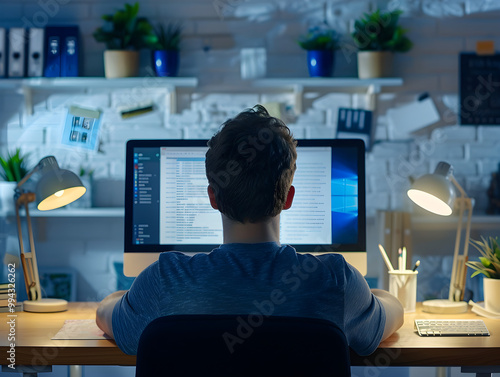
[16,192,42,301]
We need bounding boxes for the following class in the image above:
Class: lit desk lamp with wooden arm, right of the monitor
[408,162,474,313]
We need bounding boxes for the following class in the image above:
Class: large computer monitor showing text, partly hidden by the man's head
[124,139,366,276]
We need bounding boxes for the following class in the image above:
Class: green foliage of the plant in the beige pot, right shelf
[352,9,413,52]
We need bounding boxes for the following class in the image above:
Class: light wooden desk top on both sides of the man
[0,302,500,366]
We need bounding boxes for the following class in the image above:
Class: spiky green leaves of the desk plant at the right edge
[466,237,500,279]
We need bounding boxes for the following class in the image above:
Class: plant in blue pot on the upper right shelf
[298,25,339,77]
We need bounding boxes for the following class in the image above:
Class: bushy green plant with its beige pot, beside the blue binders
[93,3,157,78]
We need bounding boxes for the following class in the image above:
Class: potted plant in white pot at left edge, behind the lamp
[0,148,29,212]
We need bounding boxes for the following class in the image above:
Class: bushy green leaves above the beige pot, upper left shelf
[93,3,158,50]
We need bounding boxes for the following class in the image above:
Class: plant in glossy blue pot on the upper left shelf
[152,23,182,77]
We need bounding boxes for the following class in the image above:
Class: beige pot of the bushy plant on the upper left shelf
[104,50,139,79]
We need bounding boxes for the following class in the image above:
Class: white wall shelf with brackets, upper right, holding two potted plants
[253,77,403,114]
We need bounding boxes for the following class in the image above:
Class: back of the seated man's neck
[222,215,280,244]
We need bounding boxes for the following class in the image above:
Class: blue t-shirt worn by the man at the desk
[112,242,385,355]
